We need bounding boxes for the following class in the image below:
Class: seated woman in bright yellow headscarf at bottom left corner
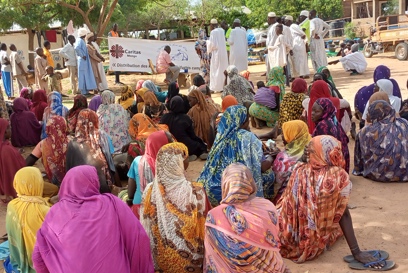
[6,167,50,273]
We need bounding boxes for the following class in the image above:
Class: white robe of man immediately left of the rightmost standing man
[290,24,310,78]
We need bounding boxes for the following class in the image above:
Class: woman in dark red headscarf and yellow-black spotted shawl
[279,78,307,126]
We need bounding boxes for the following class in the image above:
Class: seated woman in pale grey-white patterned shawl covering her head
[96,90,130,153]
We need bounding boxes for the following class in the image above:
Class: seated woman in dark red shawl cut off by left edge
[0,118,25,203]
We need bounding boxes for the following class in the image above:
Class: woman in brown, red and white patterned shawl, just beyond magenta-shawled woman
[75,108,113,185]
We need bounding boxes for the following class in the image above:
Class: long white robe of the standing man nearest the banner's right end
[207,28,228,92]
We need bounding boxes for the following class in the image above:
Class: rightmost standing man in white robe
[309,10,330,71]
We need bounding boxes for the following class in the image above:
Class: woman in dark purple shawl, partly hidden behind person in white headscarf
[354,65,401,113]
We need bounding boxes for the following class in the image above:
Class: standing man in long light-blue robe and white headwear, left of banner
[75,28,98,96]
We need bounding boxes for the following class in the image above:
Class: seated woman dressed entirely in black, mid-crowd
[160,96,207,161]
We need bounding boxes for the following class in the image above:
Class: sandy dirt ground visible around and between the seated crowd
[0,51,408,273]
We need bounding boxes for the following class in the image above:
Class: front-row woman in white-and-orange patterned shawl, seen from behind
[140,142,210,272]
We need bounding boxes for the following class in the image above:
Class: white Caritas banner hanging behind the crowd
[108,37,200,72]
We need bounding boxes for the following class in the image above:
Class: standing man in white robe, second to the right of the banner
[228,19,248,72]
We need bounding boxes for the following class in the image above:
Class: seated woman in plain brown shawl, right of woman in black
[187,90,217,148]
